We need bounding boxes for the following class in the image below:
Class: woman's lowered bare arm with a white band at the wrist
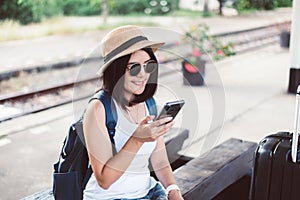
[151,136,183,200]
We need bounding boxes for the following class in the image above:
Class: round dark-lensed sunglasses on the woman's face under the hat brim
[127,60,158,76]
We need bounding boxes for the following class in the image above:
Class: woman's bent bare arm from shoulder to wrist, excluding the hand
[83,101,142,189]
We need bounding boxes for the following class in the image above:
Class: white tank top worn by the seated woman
[83,101,157,200]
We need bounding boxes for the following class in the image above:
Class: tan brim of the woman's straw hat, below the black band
[97,40,165,76]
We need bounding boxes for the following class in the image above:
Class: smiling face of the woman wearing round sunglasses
[124,50,150,99]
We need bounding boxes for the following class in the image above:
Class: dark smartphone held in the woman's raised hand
[155,100,185,120]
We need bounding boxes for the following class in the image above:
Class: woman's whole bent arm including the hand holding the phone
[83,101,170,189]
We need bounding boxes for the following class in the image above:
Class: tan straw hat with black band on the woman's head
[97,25,165,76]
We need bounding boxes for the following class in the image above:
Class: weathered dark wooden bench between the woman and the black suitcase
[174,139,257,200]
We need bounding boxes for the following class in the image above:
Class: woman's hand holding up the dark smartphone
[132,116,174,142]
